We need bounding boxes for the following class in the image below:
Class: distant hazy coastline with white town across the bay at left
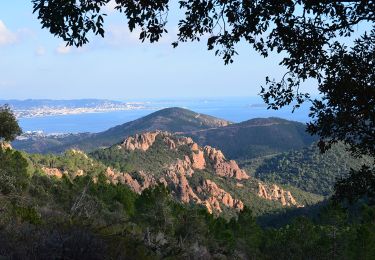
[0,99,147,118]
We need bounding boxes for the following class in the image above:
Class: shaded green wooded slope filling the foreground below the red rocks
[0,143,375,259]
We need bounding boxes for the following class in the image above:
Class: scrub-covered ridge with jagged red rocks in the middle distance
[90,131,318,214]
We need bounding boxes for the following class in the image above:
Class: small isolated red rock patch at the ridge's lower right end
[258,182,303,207]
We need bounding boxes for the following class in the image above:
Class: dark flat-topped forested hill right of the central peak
[184,118,317,159]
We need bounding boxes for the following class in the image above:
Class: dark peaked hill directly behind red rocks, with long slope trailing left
[12,107,230,153]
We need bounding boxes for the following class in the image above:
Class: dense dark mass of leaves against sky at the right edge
[308,29,375,158]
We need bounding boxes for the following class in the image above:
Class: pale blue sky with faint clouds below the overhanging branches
[0,0,316,100]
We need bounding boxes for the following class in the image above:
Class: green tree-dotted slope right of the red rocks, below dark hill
[248,144,372,196]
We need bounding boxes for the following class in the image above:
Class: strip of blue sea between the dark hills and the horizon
[19,97,309,134]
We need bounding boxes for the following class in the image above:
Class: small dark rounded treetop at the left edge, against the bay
[0,105,22,142]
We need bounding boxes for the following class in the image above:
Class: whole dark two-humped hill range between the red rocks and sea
[13,108,316,156]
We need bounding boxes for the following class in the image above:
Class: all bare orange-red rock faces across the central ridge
[107,131,300,213]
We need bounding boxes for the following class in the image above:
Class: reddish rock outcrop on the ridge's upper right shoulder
[204,146,249,180]
